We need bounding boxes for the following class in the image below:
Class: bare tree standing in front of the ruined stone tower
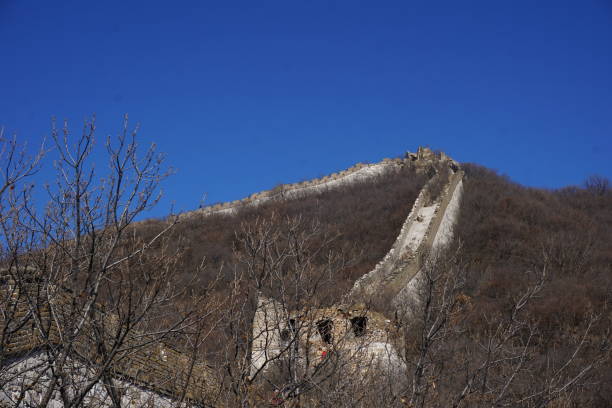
[215,216,406,406]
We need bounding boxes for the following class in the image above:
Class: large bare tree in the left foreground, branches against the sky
[0,116,218,407]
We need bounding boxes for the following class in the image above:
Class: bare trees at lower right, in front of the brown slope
[405,246,610,407]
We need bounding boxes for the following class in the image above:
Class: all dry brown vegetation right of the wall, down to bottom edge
[416,165,612,407]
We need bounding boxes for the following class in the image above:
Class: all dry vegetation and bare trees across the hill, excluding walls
[0,122,612,407]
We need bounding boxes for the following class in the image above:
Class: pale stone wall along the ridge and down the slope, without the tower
[189,147,463,312]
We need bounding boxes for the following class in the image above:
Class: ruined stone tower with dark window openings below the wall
[251,296,405,379]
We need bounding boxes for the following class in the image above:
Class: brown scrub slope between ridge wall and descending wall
[138,167,425,305]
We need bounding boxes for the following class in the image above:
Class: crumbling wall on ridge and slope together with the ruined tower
[246,148,464,376]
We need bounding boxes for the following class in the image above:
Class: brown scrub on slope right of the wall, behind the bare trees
[456,165,612,406]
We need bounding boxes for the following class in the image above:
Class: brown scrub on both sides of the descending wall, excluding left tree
[126,165,612,407]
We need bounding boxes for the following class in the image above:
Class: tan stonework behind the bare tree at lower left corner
[0,270,217,401]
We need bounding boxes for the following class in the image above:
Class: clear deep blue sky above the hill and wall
[0,0,612,218]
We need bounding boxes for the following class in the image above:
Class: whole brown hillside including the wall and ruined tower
[2,148,612,407]
